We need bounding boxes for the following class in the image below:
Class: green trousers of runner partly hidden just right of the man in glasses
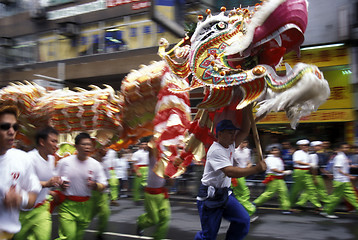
[91,191,111,235]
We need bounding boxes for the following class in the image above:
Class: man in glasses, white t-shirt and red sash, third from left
[57,132,107,239]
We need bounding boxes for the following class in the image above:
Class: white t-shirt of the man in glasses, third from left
[57,155,107,197]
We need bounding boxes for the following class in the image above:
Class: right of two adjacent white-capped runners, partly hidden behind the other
[298,141,329,205]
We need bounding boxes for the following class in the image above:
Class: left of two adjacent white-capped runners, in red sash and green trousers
[290,139,322,209]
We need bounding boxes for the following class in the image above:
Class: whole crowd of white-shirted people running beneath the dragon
[0,106,358,240]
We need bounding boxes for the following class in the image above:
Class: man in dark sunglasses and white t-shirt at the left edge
[0,106,41,239]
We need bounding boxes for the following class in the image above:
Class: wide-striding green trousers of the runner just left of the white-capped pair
[254,176,291,210]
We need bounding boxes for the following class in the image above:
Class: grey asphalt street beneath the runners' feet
[53,199,358,240]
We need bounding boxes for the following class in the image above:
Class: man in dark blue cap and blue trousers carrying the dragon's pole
[194,118,266,240]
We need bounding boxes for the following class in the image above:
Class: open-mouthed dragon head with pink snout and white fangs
[161,0,307,88]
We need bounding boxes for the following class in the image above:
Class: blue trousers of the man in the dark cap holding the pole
[194,194,250,240]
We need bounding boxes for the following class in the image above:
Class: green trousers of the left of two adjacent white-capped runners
[290,169,322,208]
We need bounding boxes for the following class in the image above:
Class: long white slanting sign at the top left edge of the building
[48,0,107,20]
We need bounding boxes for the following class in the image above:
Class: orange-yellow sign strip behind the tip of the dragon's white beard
[258,109,354,124]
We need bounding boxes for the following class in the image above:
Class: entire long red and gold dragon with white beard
[0,0,330,177]
